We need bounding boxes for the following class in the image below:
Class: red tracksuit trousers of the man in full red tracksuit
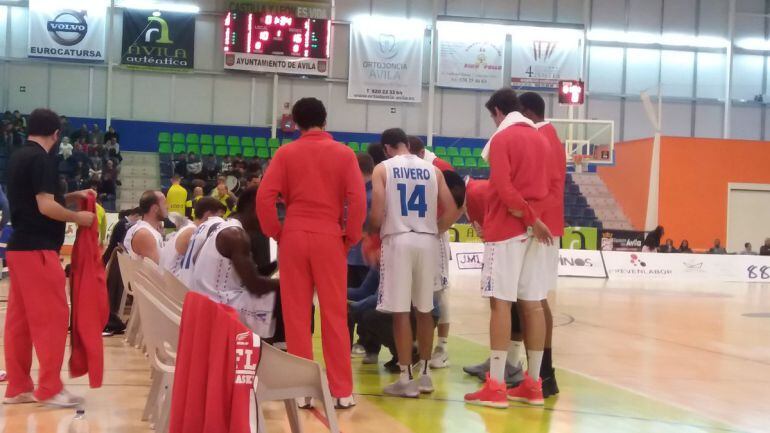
[278,231,353,398]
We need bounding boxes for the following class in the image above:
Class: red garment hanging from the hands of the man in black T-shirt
[70,195,110,388]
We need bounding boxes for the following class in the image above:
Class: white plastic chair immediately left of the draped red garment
[134,282,181,433]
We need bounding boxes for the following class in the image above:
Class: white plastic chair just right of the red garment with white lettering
[255,344,339,433]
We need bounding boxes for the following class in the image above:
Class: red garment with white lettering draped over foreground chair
[169,292,260,433]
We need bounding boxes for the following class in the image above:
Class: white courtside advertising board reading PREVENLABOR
[603,251,770,283]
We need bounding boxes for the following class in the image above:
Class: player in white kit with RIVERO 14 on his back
[370,128,459,398]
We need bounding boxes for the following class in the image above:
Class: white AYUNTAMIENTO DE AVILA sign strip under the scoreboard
[225,53,329,77]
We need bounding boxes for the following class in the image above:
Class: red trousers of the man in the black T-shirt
[5,251,69,400]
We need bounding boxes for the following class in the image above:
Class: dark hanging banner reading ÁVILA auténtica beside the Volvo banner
[120,9,195,70]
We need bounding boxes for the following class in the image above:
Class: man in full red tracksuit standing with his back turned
[257,98,366,408]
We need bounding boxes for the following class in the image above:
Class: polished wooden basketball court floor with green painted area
[0,279,770,433]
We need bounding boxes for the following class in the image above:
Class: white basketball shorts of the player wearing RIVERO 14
[377,232,441,313]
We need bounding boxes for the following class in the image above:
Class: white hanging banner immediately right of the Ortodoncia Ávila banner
[436,21,507,90]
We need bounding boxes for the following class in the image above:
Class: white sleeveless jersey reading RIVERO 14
[380,155,438,237]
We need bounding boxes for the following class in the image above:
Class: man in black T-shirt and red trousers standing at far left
[4,109,94,407]
